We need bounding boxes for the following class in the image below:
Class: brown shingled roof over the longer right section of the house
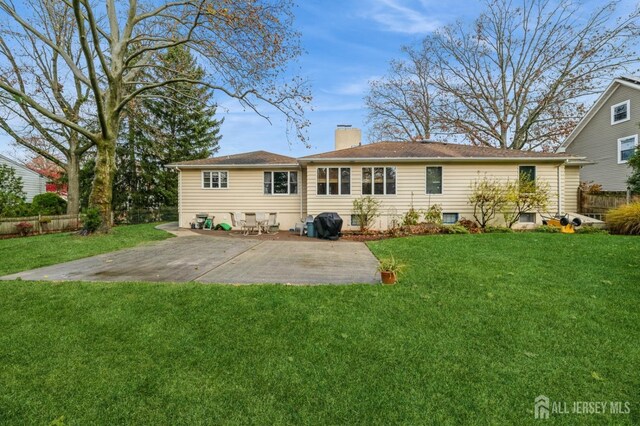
[299,141,575,162]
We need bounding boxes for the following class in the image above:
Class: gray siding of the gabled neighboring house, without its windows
[566,86,640,191]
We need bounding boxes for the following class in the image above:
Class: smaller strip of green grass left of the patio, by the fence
[0,223,172,276]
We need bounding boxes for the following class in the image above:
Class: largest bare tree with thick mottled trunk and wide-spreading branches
[0,0,309,228]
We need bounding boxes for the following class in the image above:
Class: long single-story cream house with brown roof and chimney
[168,127,582,230]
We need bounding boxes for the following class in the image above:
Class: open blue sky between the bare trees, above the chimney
[0,0,635,161]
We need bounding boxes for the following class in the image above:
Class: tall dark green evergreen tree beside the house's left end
[114,46,223,210]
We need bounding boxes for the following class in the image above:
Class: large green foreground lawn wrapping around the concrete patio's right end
[0,233,640,425]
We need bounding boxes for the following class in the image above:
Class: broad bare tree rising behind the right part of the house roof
[364,0,640,150]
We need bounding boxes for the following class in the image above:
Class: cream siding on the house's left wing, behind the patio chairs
[179,168,303,230]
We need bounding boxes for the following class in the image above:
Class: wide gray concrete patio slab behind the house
[0,226,379,284]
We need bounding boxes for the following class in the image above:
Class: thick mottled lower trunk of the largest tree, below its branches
[89,137,116,232]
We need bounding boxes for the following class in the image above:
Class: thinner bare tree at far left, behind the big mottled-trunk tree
[0,0,92,214]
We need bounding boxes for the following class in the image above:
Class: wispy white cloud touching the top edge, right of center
[365,0,442,34]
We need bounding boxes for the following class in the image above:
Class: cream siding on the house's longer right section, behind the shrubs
[307,162,577,229]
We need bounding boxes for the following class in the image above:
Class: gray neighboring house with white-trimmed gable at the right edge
[558,77,640,191]
